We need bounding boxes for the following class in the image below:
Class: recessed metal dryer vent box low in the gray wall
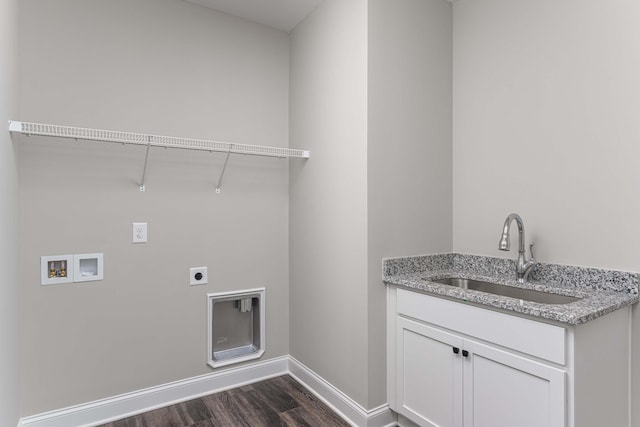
[207,288,265,368]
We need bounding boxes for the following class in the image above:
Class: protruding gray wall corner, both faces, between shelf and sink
[290,0,452,409]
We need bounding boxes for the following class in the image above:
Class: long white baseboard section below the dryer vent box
[18,356,288,427]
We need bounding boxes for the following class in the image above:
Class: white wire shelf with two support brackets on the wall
[9,120,311,193]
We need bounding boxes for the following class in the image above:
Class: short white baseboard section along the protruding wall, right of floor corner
[289,356,396,427]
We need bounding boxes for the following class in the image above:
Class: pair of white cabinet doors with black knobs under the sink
[395,317,565,427]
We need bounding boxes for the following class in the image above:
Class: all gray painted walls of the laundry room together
[15,0,640,427]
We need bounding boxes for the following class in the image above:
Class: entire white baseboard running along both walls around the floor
[18,356,396,427]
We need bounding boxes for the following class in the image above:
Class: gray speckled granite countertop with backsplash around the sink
[382,254,639,325]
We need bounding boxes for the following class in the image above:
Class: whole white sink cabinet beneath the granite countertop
[387,287,628,427]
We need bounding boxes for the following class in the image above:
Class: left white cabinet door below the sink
[396,317,463,427]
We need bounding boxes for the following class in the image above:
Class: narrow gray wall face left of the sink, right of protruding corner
[367,0,452,407]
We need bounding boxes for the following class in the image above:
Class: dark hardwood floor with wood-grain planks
[101,375,349,427]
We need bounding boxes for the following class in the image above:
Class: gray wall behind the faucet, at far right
[453,0,640,426]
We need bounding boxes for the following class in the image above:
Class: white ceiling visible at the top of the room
[186,0,322,32]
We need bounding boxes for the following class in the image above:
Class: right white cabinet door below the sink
[463,341,565,427]
